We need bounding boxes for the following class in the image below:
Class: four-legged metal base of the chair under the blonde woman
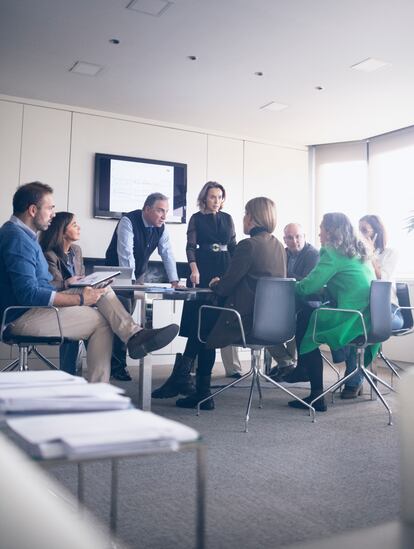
[197,348,315,433]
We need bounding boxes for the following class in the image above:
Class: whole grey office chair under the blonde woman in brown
[197,277,315,433]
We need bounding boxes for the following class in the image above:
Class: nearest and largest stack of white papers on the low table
[7,409,199,458]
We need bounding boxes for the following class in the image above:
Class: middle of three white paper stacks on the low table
[0,382,131,413]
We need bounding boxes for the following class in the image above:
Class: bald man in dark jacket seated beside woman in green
[268,223,319,380]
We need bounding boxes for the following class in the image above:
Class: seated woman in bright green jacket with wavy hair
[289,213,375,412]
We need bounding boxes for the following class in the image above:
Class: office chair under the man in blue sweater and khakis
[0,306,65,372]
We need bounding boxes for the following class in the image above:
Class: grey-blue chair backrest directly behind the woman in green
[368,280,391,343]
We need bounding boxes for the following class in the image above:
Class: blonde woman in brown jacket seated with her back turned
[176,197,286,410]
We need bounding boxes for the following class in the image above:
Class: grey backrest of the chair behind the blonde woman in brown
[251,277,296,345]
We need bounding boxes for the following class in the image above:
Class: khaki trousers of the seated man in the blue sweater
[12,288,142,383]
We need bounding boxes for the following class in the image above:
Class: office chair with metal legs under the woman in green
[311,280,395,425]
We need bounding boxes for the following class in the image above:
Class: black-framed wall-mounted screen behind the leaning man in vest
[93,153,187,223]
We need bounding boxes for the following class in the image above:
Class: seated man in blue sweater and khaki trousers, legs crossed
[0,181,178,382]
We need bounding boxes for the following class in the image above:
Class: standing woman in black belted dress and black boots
[152,181,236,406]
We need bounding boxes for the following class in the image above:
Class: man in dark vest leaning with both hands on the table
[105,193,178,381]
